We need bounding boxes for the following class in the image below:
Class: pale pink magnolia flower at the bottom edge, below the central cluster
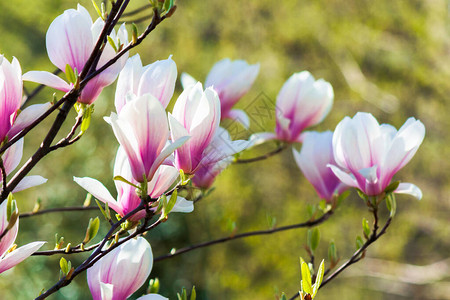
[87,237,153,300]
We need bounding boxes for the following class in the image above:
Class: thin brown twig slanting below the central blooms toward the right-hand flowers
[153,210,333,262]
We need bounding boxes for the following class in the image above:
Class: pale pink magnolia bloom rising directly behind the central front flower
[115,54,177,113]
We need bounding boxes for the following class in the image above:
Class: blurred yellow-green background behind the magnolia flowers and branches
[0,0,450,300]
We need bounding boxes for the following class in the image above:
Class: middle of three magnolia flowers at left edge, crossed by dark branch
[0,138,47,193]
